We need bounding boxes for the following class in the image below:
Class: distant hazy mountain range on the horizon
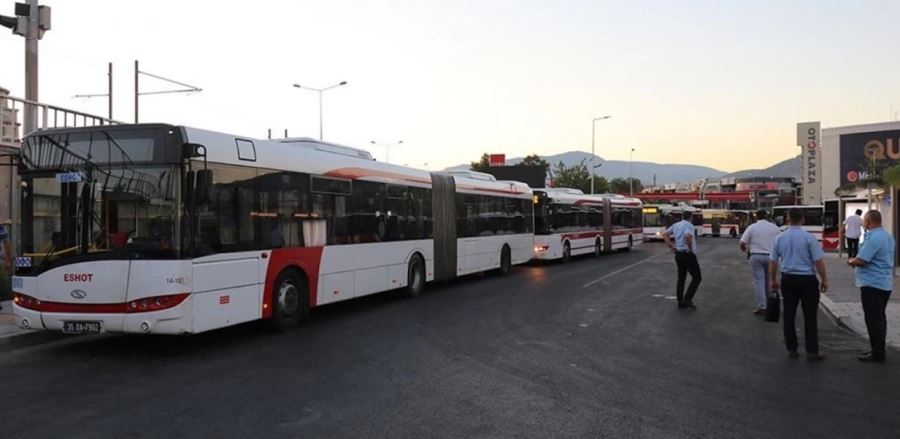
[447,151,800,184]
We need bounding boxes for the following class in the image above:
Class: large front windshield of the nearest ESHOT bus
[17,130,179,274]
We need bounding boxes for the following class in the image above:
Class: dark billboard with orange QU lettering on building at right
[840,130,900,186]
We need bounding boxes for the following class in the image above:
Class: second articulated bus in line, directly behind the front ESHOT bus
[534,188,644,262]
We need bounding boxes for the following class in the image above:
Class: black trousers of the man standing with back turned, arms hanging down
[781,273,819,354]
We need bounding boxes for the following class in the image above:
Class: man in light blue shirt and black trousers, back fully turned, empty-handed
[769,209,828,361]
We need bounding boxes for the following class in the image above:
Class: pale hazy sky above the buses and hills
[0,0,900,172]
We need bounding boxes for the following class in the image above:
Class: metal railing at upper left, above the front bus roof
[0,95,123,147]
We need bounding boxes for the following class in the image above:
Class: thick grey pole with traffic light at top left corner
[0,0,50,134]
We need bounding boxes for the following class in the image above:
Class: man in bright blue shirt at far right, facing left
[847,210,895,363]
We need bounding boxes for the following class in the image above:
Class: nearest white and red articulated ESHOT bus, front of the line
[13,124,534,334]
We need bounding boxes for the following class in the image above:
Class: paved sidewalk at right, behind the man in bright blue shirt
[821,253,900,349]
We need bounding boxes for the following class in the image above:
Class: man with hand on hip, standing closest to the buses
[663,210,702,309]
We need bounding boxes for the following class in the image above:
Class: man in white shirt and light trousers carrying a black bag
[741,210,781,315]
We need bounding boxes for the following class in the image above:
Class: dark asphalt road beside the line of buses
[0,238,900,438]
